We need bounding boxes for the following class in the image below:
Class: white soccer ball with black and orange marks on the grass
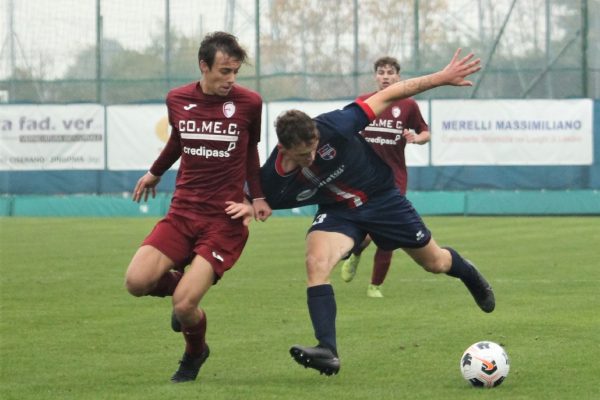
[460,341,510,388]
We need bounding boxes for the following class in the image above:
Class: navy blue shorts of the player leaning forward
[308,190,431,250]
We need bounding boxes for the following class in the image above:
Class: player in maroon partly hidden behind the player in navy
[341,57,431,297]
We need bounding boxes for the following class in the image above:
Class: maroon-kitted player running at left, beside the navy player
[125,32,271,382]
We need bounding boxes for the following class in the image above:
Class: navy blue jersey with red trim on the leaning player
[261,101,395,209]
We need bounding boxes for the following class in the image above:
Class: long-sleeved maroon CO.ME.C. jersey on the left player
[150,82,263,217]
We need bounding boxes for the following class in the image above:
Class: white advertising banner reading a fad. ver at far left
[0,104,105,171]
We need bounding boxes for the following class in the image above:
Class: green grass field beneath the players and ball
[0,217,600,400]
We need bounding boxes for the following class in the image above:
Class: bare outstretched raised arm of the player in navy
[365,48,481,115]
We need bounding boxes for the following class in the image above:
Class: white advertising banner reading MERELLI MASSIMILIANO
[431,99,593,166]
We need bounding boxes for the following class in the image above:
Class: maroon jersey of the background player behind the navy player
[359,93,429,194]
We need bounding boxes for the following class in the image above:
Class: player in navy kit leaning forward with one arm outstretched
[261,49,495,375]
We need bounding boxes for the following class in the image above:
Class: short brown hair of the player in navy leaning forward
[275,110,319,149]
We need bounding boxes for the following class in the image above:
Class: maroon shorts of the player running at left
[142,213,248,278]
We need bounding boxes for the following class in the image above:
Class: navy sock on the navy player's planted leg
[306,284,337,355]
